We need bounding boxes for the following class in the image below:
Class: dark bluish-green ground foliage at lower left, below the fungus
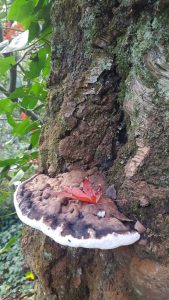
[0,220,33,299]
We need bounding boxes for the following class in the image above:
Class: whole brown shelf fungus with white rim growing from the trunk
[14,170,140,249]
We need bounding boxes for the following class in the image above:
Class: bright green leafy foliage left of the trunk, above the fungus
[0,0,51,181]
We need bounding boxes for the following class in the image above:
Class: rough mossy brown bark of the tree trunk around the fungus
[22,0,169,300]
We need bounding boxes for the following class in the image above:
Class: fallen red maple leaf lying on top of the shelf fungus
[53,177,102,203]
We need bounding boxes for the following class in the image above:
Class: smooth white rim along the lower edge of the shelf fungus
[14,179,140,249]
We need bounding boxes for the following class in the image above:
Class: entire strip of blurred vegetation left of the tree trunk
[0,0,52,300]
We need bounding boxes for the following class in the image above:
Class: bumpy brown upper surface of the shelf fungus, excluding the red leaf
[15,171,139,247]
